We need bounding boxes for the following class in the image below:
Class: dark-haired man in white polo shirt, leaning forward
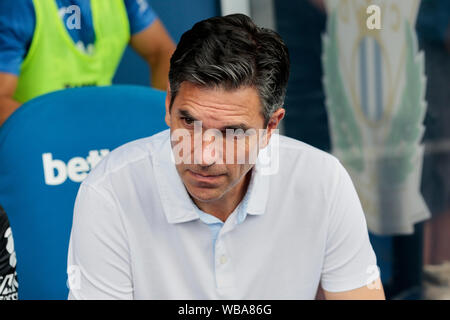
[68,15,384,299]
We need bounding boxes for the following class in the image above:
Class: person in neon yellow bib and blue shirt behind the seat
[0,0,175,125]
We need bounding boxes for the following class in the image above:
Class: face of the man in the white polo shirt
[165,82,284,202]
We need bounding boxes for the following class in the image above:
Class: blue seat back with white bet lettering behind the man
[0,86,167,299]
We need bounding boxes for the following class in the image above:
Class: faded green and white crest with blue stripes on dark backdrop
[323,0,430,234]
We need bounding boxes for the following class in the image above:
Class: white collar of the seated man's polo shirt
[153,129,270,223]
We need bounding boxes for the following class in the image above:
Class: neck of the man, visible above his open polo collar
[192,169,253,222]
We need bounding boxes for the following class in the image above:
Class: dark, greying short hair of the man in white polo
[169,14,290,125]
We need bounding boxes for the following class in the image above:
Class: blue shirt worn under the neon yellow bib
[0,0,156,75]
